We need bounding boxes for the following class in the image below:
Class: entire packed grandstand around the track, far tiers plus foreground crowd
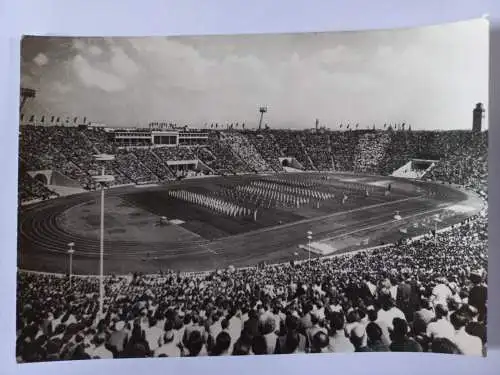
[16,126,488,362]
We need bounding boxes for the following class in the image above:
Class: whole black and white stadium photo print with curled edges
[16,19,489,363]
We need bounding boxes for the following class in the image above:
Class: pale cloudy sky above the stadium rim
[21,19,489,130]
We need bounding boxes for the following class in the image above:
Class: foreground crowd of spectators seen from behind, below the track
[16,207,488,362]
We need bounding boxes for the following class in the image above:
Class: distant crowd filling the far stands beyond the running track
[20,125,488,199]
